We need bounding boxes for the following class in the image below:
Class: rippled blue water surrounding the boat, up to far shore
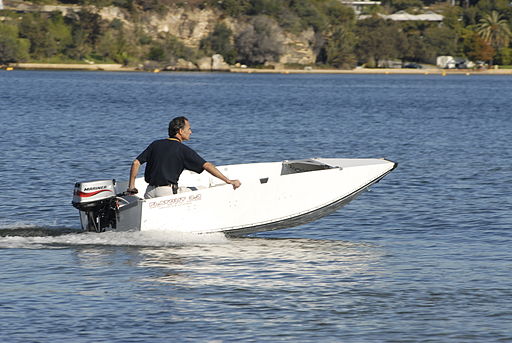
[0,71,512,343]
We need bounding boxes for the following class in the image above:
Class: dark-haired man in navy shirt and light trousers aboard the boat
[127,117,241,199]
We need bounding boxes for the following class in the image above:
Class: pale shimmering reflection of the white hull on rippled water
[139,238,383,290]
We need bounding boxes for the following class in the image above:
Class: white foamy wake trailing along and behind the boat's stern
[0,226,228,249]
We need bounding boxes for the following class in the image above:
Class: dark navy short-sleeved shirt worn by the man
[137,139,206,186]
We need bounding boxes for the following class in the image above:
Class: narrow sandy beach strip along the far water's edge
[6,63,512,75]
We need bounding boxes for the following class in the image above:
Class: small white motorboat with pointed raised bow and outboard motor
[73,158,397,236]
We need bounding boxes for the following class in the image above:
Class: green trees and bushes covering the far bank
[0,0,512,68]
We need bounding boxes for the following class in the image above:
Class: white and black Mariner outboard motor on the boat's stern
[72,180,117,232]
